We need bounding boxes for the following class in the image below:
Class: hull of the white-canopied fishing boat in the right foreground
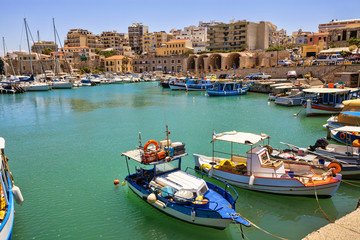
[193,154,341,197]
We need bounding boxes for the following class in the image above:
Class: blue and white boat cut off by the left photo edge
[0,137,23,239]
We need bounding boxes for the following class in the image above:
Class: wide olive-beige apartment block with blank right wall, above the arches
[207,20,270,51]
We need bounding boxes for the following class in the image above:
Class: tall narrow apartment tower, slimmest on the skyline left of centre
[128,23,149,54]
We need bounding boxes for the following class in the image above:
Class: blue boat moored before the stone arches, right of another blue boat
[206,81,252,96]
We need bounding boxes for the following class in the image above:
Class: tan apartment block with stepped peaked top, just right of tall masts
[64,29,103,48]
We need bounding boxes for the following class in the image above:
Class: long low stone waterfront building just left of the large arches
[132,55,186,73]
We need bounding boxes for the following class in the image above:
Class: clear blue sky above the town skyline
[0,0,360,56]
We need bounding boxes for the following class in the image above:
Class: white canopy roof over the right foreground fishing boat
[212,131,269,145]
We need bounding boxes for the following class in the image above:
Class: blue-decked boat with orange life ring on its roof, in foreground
[122,126,250,229]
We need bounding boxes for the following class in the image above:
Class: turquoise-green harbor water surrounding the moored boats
[0,83,360,240]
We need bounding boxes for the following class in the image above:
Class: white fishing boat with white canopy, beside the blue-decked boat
[194,131,341,197]
